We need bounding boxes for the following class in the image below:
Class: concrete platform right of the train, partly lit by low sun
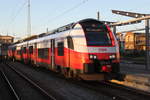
[111,63,150,92]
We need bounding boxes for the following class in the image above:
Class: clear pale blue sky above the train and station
[0,0,150,38]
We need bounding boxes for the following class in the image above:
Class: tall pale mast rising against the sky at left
[27,0,31,36]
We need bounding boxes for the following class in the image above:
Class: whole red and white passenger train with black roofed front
[8,19,120,80]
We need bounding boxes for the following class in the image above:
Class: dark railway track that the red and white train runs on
[8,61,150,100]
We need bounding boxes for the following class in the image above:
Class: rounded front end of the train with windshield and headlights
[80,20,120,79]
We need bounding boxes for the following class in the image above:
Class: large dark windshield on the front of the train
[84,24,112,46]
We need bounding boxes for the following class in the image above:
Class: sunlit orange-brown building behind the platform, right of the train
[116,32,146,53]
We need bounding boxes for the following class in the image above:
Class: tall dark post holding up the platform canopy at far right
[145,19,150,70]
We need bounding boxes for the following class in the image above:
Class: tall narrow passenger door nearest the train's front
[51,39,55,69]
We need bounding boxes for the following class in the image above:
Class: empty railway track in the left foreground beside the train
[3,63,63,100]
